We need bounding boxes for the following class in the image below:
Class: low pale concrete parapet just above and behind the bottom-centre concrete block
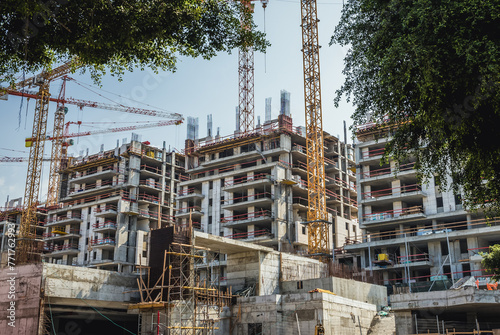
[282,277,387,308]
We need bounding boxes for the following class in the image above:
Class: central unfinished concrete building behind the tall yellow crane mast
[176,115,360,270]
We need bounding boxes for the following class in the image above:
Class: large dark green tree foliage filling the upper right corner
[330,0,500,214]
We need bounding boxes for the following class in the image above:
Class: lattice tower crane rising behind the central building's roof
[238,0,269,132]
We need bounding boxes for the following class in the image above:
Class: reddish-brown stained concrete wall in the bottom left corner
[0,264,42,335]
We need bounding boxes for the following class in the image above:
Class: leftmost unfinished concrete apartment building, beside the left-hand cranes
[44,141,184,272]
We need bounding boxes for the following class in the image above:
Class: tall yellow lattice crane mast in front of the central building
[300,0,330,261]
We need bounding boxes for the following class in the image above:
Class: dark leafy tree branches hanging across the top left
[0,0,268,80]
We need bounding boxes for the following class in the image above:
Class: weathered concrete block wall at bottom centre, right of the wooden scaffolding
[232,293,376,335]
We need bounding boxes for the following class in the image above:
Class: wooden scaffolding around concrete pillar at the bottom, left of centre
[129,225,232,335]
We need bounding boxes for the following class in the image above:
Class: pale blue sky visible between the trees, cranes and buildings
[0,0,354,206]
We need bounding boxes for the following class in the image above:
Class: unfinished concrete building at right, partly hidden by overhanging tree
[344,124,500,334]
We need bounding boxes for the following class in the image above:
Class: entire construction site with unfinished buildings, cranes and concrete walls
[0,0,500,335]
